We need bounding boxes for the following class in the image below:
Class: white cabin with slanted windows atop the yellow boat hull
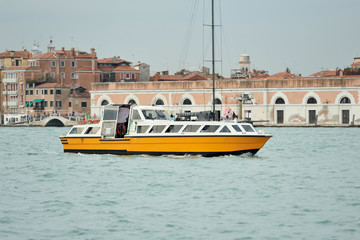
[68,104,259,140]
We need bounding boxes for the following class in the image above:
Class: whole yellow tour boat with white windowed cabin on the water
[60,104,271,156]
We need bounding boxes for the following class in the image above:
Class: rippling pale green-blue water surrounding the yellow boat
[0,128,360,239]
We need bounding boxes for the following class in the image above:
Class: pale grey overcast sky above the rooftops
[0,0,360,77]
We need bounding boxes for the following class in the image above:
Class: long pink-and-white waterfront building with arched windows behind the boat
[91,76,360,126]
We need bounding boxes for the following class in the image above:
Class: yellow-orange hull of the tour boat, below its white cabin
[60,135,271,157]
